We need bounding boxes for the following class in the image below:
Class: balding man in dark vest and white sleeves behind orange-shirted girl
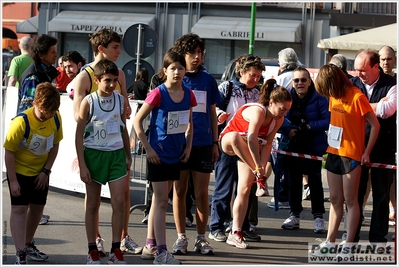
[351,49,396,247]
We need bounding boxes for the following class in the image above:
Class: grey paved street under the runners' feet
[2,170,394,265]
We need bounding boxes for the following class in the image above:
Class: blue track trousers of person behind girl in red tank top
[209,150,252,234]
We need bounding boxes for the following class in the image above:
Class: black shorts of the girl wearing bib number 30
[147,160,181,182]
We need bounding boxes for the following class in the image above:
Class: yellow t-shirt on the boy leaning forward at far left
[3,107,63,176]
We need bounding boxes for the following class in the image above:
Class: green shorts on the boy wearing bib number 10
[84,147,127,185]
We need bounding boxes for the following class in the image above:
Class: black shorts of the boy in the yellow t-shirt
[7,173,48,206]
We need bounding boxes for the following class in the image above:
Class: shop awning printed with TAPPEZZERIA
[49,11,155,35]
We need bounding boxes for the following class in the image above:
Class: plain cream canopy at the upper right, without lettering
[317,23,398,53]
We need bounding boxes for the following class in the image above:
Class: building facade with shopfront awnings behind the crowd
[14,2,397,84]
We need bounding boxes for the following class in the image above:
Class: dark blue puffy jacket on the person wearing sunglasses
[279,83,330,156]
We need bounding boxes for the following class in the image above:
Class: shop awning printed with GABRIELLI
[191,16,301,43]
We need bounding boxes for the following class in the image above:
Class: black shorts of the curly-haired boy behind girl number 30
[181,145,213,173]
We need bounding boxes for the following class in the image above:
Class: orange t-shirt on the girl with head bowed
[327,87,374,161]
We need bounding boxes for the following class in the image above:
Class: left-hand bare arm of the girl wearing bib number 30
[133,102,161,164]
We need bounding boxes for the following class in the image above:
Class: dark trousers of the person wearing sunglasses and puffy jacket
[285,158,326,216]
